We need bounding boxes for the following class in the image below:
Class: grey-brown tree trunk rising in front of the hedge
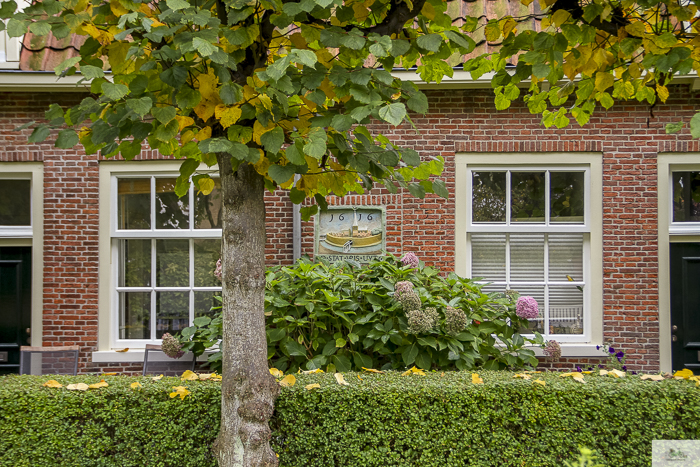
[214,154,279,467]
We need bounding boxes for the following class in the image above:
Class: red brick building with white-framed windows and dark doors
[0,28,700,372]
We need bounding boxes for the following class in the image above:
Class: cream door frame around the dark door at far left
[0,162,44,352]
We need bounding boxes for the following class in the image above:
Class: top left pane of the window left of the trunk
[117,178,151,229]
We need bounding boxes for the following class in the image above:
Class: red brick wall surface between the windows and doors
[0,87,700,371]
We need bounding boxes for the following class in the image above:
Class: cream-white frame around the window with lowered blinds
[455,153,603,357]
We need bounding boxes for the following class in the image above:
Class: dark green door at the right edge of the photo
[671,243,700,374]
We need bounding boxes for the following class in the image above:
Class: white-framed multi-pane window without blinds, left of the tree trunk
[110,172,221,347]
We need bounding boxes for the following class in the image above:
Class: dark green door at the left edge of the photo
[0,247,32,374]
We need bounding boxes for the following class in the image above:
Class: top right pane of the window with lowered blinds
[549,172,585,224]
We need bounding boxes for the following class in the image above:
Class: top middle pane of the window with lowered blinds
[510,172,545,223]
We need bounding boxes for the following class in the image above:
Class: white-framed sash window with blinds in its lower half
[466,164,591,342]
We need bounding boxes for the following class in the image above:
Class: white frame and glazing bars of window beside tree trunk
[93,161,222,352]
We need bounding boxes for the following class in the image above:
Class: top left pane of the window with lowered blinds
[472,172,506,222]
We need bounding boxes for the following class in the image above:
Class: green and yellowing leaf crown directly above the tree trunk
[0,0,482,215]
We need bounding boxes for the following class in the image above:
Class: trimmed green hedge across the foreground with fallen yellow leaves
[0,372,700,467]
